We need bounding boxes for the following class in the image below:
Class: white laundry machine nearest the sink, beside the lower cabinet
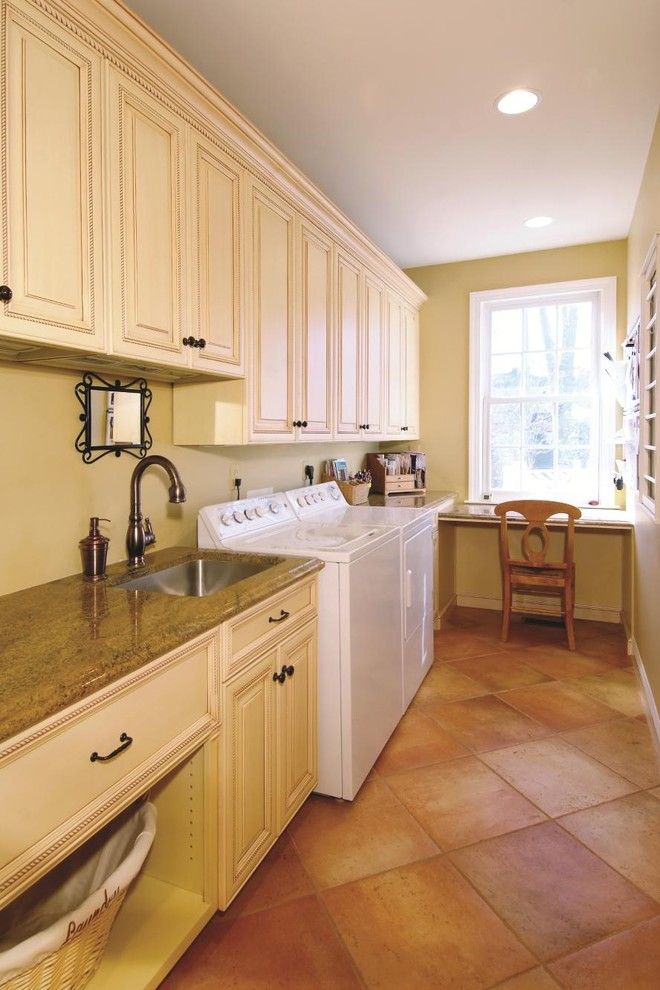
[197,485,401,800]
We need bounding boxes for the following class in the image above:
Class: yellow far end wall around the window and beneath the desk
[408,241,631,620]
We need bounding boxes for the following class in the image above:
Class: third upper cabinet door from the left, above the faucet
[189,131,244,376]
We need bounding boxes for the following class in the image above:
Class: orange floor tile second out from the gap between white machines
[424,695,549,753]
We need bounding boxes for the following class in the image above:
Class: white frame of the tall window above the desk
[468,276,617,506]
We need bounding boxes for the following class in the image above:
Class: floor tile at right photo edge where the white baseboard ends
[562,718,660,787]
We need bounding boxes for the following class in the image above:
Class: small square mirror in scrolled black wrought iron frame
[75,371,153,464]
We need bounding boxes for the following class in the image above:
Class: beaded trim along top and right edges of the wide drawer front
[0,632,219,764]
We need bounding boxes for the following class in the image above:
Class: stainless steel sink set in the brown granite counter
[117,557,272,598]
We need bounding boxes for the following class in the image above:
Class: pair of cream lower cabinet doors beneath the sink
[219,619,317,909]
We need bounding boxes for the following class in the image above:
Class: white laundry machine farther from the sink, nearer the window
[286,482,434,714]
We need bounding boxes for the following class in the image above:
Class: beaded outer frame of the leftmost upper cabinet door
[0,0,97,336]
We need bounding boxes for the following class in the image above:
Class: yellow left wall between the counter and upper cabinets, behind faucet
[0,362,373,594]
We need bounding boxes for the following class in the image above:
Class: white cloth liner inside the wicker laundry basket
[0,802,156,985]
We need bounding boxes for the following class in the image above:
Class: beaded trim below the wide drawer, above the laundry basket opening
[0,717,213,895]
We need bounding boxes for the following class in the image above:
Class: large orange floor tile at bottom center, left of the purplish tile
[323,857,535,990]
